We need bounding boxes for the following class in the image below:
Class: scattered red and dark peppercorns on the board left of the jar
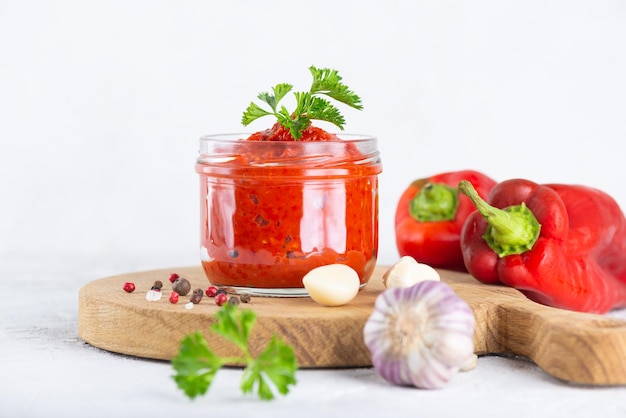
[122,273,250,309]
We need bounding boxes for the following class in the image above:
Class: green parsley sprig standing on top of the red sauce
[241,66,363,140]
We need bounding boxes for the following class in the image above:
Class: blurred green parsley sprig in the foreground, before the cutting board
[172,304,298,400]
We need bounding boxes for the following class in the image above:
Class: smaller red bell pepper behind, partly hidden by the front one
[395,170,496,271]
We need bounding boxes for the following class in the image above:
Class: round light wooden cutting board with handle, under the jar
[78,266,626,385]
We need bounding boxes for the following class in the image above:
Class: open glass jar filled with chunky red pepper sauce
[196,134,382,296]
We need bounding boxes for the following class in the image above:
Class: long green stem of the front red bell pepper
[459,180,541,257]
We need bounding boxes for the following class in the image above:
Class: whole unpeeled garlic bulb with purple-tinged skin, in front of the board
[363,280,476,389]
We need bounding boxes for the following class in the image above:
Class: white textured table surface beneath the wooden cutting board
[0,256,626,418]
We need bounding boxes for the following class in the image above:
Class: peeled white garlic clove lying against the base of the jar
[302,264,361,306]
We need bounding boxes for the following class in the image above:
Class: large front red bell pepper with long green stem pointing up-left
[459,179,626,313]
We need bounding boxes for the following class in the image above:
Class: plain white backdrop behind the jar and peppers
[0,0,626,268]
